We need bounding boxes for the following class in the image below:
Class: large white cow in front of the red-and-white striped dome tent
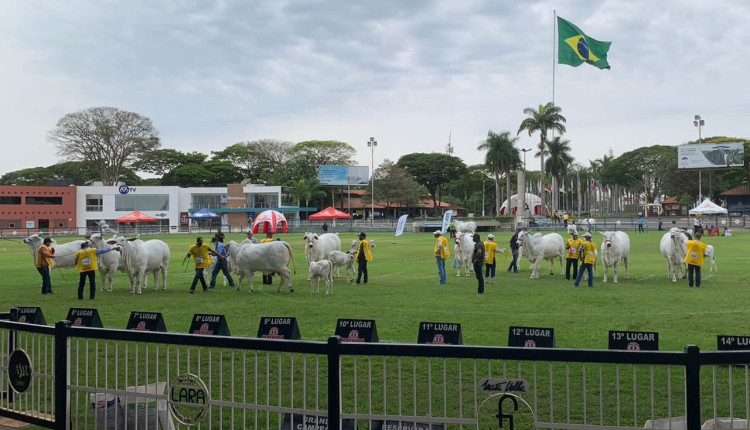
[225,240,294,292]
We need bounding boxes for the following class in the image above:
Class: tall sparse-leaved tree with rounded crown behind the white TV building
[49,107,160,185]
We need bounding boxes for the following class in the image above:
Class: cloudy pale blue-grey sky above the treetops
[0,0,750,174]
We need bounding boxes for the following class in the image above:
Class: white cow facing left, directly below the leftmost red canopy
[107,236,171,294]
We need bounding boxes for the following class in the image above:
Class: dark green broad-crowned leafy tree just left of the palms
[396,152,468,210]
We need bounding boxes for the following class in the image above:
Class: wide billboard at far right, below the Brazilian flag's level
[677,142,745,169]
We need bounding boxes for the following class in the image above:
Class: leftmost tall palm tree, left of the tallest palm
[477,130,521,216]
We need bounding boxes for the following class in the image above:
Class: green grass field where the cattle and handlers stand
[0,232,750,350]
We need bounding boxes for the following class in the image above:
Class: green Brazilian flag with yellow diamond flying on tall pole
[557,16,612,69]
